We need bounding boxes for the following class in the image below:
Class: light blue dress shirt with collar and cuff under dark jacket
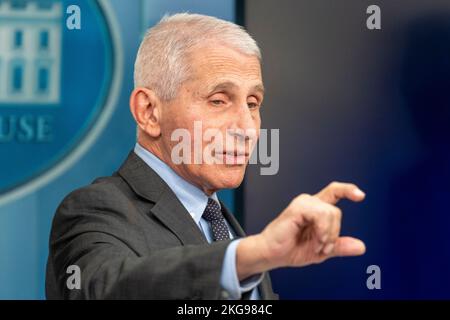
[134,143,262,300]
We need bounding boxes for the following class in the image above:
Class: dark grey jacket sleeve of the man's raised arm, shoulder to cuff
[46,185,230,299]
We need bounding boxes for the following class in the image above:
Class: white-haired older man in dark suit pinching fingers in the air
[46,14,365,299]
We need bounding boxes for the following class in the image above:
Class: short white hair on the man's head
[134,13,261,101]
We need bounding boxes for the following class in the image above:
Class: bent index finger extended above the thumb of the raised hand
[315,182,366,204]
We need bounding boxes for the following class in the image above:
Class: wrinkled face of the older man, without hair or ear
[161,45,264,194]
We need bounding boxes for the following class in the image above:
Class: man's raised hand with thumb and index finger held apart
[237,182,365,279]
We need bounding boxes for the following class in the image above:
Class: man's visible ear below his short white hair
[130,87,161,138]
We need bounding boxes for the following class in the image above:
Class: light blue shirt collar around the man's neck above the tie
[134,143,220,225]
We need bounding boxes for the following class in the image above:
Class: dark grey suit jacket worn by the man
[46,152,277,299]
